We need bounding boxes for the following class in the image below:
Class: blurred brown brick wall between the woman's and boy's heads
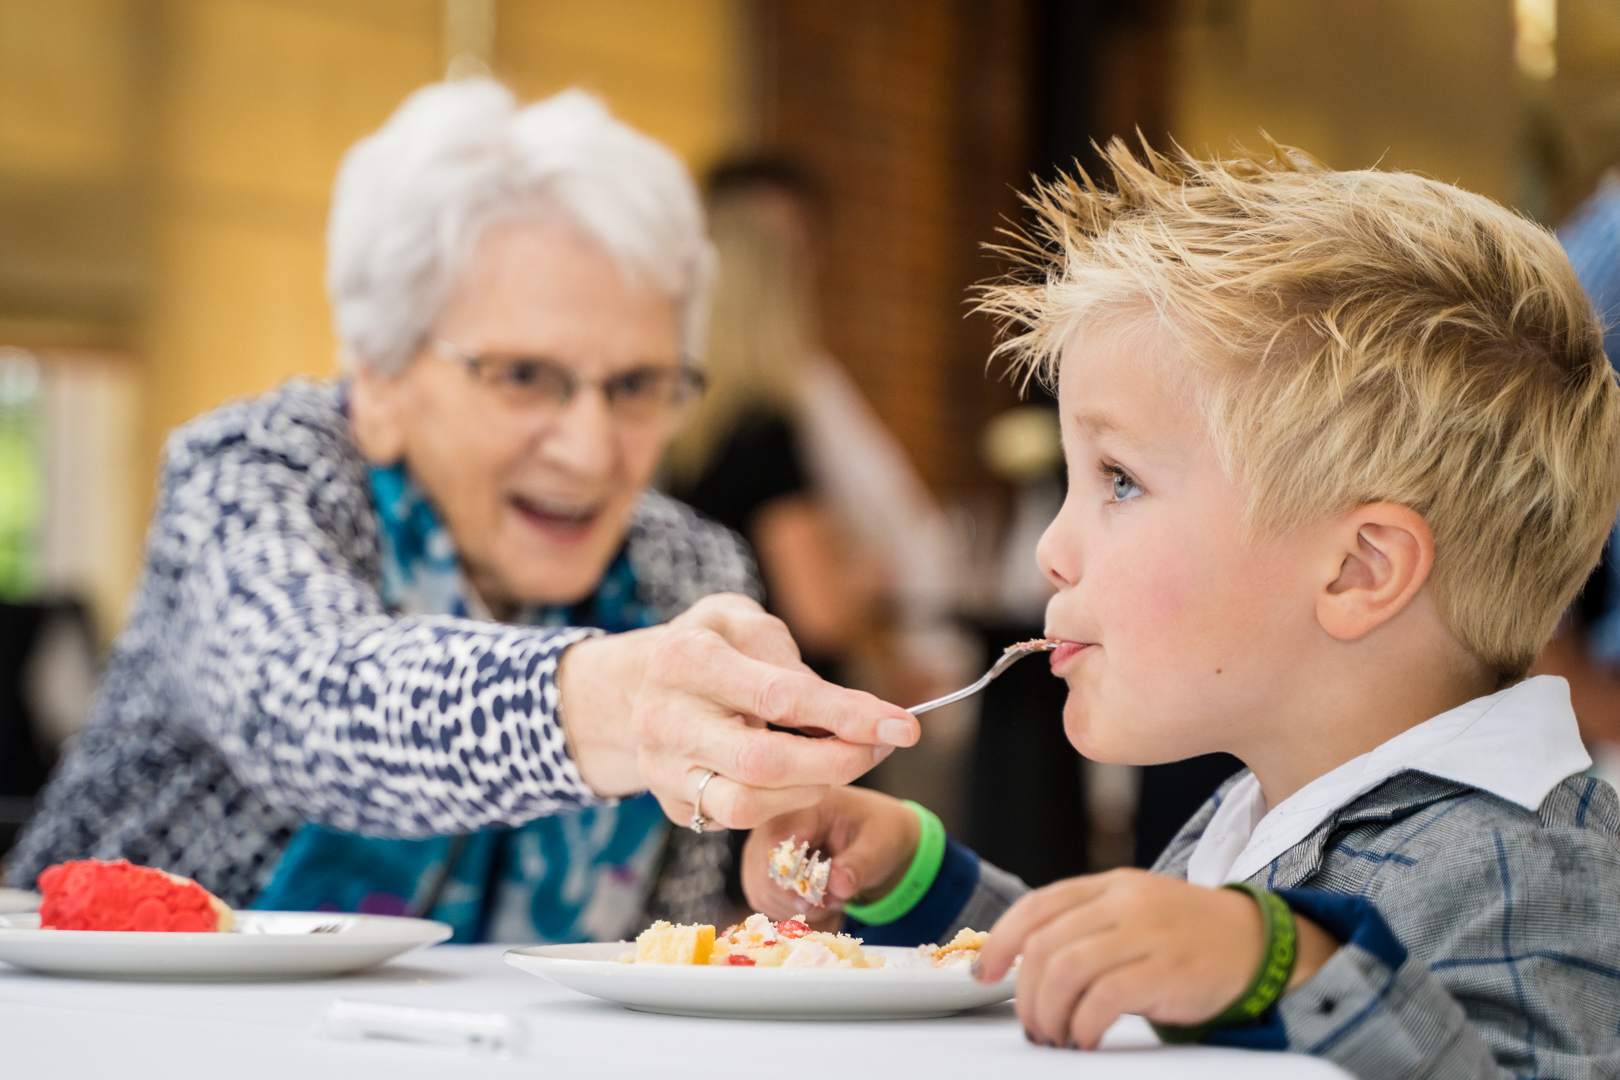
[757,0,1030,489]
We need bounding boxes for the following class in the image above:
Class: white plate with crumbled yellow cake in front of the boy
[505,915,1016,1020]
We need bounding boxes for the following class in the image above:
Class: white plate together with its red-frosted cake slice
[0,860,452,981]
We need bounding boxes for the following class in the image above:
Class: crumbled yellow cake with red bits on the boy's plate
[633,915,883,968]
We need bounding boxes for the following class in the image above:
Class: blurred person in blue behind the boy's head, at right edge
[1536,168,1620,785]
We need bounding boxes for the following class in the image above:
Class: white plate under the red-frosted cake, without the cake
[0,912,452,981]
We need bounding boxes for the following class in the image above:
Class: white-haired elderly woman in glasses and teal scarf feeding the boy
[6,81,919,941]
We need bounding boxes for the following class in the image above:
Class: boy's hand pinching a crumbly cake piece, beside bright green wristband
[742,787,922,929]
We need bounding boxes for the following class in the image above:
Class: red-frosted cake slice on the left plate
[39,858,235,934]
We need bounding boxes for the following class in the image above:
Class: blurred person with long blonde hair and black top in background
[666,157,962,699]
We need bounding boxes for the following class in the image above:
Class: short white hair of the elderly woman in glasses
[326,79,714,372]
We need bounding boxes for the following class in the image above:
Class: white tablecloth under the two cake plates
[0,946,1345,1080]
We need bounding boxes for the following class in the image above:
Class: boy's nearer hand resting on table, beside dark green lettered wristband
[974,870,1338,1049]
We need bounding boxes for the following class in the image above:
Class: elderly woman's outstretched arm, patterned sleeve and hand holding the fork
[164,388,919,837]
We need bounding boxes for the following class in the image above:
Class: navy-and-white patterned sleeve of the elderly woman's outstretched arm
[161,395,595,836]
